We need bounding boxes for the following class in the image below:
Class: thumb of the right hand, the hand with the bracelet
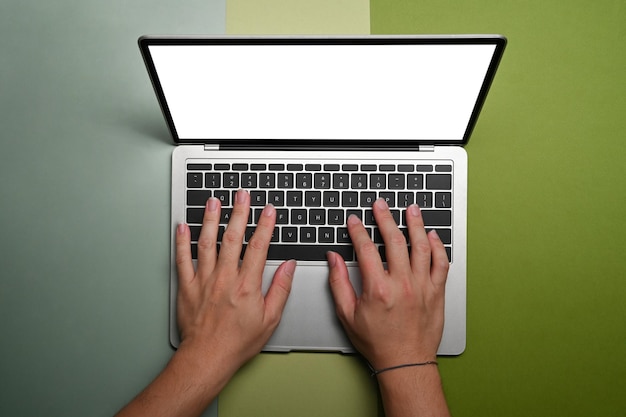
[326,252,356,327]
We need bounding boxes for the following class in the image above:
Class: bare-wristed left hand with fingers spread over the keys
[176,190,296,372]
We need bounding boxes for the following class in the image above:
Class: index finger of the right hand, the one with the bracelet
[347,214,385,293]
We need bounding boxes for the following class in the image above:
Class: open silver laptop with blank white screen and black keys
[139,35,506,355]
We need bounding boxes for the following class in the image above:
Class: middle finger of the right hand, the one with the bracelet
[372,198,411,273]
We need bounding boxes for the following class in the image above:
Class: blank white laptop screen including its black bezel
[141,37,503,143]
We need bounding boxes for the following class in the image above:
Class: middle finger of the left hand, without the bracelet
[217,190,250,267]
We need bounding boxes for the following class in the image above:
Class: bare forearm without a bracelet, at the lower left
[117,346,234,417]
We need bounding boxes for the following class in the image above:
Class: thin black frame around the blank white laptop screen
[138,35,507,150]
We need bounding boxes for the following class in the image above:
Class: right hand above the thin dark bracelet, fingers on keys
[328,199,449,369]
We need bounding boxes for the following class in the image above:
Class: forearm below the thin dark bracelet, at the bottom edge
[378,365,450,417]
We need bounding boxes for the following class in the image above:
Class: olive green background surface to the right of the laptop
[371,0,626,417]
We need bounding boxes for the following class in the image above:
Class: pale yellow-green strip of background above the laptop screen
[226,0,370,35]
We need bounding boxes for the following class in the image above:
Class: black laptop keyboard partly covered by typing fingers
[185,160,454,262]
